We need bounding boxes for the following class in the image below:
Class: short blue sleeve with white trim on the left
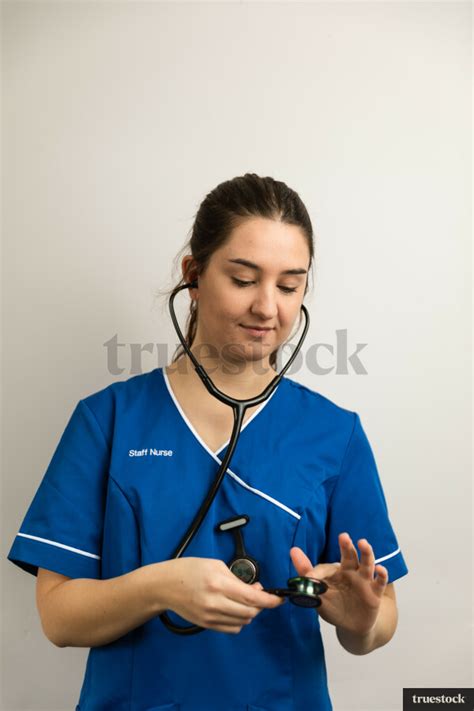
[7,400,110,578]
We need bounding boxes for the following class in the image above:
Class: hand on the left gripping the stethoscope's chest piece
[153,557,285,634]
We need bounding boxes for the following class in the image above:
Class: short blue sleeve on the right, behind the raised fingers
[319,413,408,583]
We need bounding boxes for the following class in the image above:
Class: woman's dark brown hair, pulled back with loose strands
[165,173,314,366]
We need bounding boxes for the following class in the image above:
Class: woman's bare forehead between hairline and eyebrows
[215,217,310,269]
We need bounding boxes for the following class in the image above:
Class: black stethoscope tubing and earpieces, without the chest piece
[159,282,309,635]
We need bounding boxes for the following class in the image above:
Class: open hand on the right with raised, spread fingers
[290,533,388,635]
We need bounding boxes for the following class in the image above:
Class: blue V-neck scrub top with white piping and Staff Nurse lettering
[8,368,408,711]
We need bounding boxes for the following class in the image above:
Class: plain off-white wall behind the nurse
[1,0,472,711]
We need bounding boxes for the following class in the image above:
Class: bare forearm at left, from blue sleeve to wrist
[41,561,174,647]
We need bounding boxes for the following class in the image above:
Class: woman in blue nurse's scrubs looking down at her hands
[8,174,408,711]
